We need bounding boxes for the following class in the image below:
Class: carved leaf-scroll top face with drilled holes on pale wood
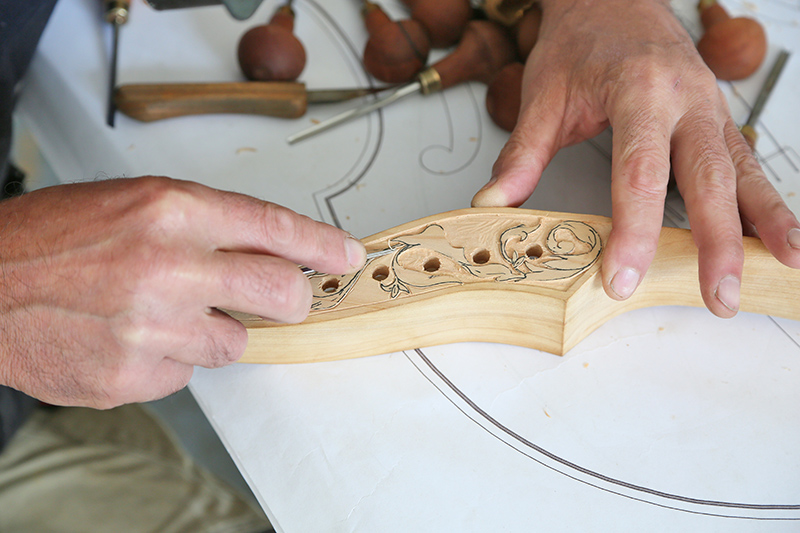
[312,213,602,311]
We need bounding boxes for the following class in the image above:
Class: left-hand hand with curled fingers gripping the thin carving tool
[0,177,366,408]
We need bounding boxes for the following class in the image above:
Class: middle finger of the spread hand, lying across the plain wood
[673,110,744,318]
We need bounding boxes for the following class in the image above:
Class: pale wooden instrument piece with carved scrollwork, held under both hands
[236,208,800,363]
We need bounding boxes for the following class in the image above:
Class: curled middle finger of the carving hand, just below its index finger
[203,251,312,323]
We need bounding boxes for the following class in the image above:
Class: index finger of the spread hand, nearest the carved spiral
[602,103,671,300]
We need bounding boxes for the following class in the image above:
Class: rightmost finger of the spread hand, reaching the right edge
[725,120,800,268]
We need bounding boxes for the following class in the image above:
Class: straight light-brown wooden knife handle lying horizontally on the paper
[114,82,308,122]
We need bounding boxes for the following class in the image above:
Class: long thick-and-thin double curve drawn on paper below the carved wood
[410,349,800,521]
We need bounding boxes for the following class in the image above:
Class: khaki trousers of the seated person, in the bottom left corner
[0,405,271,533]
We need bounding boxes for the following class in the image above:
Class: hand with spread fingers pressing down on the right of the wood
[473,0,800,317]
